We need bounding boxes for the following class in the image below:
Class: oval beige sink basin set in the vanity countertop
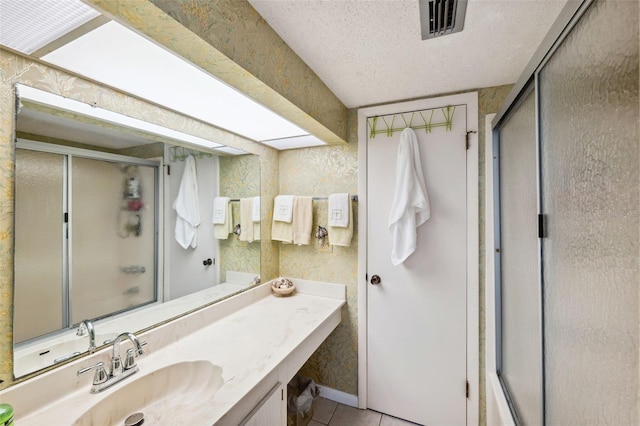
[73,361,223,426]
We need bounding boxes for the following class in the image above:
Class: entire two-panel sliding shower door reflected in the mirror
[14,141,158,343]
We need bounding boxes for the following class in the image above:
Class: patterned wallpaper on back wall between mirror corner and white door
[279,110,358,394]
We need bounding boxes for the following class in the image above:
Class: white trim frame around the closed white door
[357,92,480,425]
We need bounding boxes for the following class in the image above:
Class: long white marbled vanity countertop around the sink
[0,280,345,426]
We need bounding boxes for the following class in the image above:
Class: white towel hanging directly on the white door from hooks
[389,128,431,266]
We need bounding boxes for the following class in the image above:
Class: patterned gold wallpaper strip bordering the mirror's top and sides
[0,49,279,388]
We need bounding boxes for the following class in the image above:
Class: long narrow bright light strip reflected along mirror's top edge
[16,84,223,148]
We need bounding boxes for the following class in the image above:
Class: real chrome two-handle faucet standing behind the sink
[78,332,147,393]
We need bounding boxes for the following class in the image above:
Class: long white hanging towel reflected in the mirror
[173,155,200,249]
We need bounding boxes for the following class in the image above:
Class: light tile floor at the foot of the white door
[308,398,415,426]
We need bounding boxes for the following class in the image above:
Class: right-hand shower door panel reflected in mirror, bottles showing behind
[70,157,156,324]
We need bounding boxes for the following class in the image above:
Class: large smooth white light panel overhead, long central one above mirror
[42,21,316,141]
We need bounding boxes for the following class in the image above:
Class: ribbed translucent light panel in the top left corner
[0,0,100,55]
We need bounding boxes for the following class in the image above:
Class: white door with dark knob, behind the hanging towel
[367,105,467,425]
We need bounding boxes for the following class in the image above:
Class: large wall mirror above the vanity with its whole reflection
[14,85,260,378]
